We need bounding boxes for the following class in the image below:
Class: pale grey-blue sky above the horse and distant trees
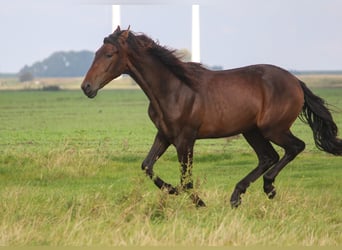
[0,0,342,73]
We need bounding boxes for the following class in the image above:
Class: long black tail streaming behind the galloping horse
[299,81,342,155]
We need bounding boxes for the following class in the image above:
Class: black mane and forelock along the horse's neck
[103,31,204,88]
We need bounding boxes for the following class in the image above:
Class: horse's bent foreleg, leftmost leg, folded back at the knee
[141,133,178,194]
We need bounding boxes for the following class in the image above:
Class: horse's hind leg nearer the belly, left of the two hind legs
[230,129,279,207]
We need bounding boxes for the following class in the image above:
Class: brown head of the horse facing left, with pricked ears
[81,26,129,98]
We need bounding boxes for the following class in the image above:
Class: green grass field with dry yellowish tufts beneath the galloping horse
[0,81,342,246]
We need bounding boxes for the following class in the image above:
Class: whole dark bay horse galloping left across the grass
[81,27,342,207]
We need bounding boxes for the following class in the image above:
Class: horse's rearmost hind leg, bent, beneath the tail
[264,131,305,199]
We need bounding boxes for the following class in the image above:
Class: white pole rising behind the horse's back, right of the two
[191,4,201,62]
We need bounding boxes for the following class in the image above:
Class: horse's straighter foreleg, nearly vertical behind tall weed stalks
[177,143,205,207]
